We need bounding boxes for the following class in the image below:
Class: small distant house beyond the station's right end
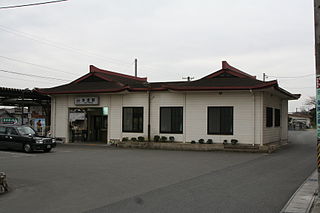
[288,112,312,130]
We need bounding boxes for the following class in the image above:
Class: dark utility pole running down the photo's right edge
[314,0,320,197]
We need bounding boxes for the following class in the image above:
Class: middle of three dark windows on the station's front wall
[160,107,183,134]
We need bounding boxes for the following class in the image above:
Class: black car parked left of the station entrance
[0,124,56,152]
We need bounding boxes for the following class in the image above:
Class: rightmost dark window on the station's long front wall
[208,107,233,135]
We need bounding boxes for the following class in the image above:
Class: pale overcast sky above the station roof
[0,0,315,111]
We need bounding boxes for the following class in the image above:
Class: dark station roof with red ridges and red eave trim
[39,61,299,99]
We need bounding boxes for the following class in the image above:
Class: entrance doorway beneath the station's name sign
[69,107,108,143]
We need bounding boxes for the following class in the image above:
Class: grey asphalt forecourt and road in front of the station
[0,131,316,213]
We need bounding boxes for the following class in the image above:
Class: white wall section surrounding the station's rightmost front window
[186,91,255,144]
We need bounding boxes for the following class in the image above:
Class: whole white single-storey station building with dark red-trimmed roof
[38,61,300,145]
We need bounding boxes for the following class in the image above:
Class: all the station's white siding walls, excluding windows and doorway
[51,91,288,144]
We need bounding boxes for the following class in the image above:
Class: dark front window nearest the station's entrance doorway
[122,107,143,132]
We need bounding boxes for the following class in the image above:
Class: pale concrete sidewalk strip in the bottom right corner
[280,170,318,213]
